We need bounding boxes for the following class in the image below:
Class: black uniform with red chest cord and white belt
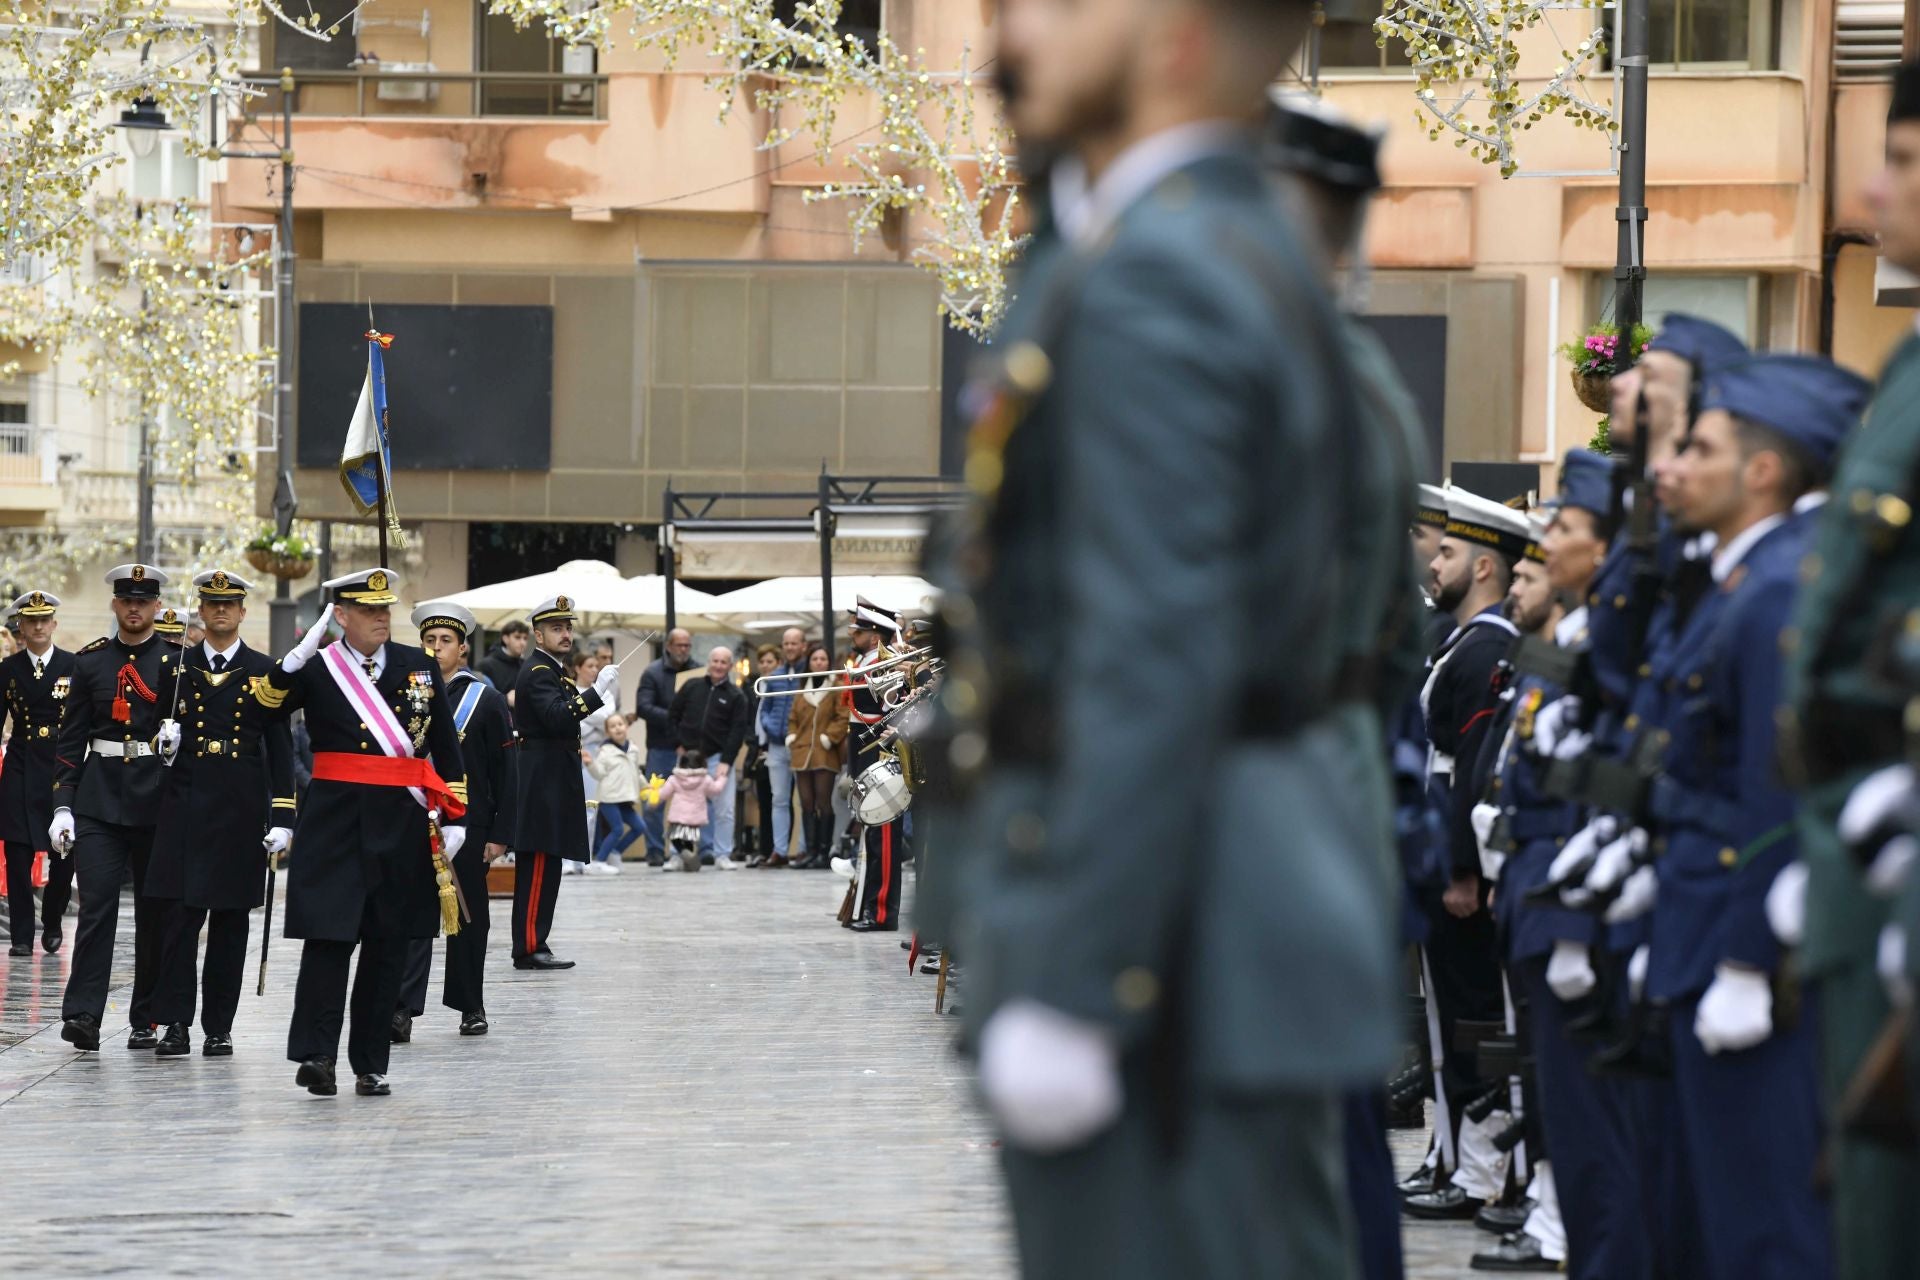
[48,633,180,1029]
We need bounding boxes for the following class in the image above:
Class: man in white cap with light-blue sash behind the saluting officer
[394,603,513,1044]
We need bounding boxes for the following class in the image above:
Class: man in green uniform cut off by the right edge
[1784,63,1920,1280]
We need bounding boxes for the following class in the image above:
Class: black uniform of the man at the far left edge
[0,649,73,950]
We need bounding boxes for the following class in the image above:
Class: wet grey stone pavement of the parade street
[0,865,1488,1280]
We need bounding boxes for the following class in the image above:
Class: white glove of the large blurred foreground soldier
[979,1000,1125,1155]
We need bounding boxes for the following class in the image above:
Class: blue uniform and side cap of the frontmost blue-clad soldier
[1647,355,1866,1280]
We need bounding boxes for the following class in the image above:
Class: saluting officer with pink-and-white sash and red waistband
[253,568,467,1096]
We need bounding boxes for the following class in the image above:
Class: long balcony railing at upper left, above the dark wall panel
[248,63,607,121]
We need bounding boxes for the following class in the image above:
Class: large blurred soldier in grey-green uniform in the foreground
[943,0,1407,1280]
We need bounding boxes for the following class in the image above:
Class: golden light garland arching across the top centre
[488,0,1023,334]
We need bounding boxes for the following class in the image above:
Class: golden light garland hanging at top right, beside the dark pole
[1373,0,1619,178]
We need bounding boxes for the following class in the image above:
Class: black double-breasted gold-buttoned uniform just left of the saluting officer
[146,643,294,1036]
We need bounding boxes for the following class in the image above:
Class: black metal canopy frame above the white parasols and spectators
[660,468,968,666]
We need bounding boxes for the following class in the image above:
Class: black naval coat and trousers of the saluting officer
[255,641,466,1075]
